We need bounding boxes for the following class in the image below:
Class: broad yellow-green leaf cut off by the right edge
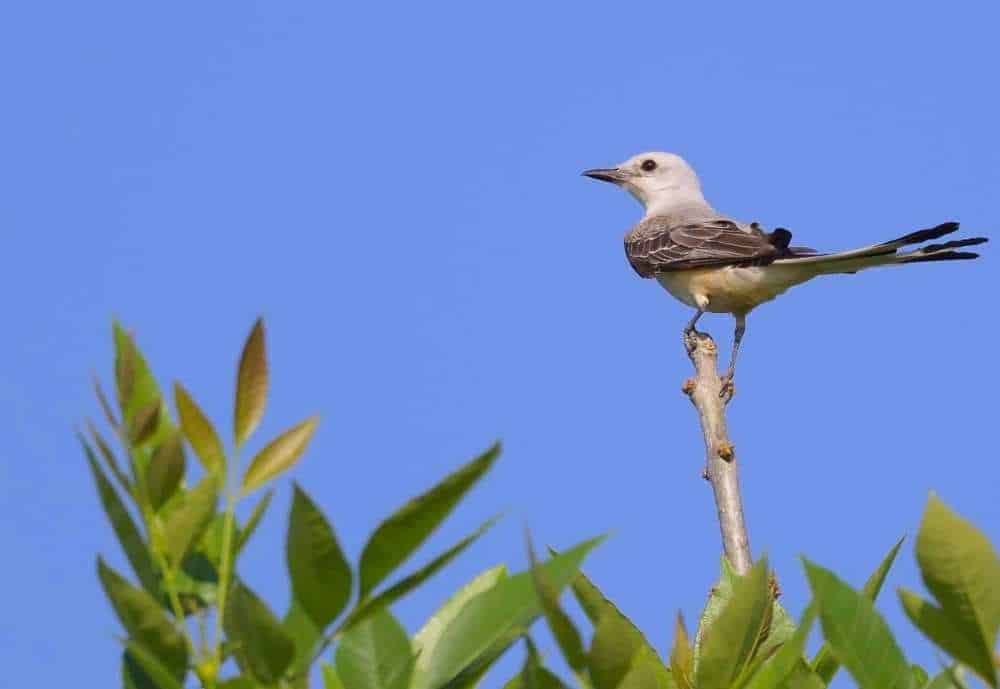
[917,495,1000,686]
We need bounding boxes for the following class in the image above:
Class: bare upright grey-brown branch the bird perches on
[683,331,752,574]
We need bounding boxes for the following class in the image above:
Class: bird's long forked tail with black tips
[775,222,989,274]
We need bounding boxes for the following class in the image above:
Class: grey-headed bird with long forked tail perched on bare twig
[582,151,988,397]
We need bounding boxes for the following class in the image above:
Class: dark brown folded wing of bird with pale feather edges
[625,217,791,277]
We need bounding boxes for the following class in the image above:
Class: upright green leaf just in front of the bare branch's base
[694,558,774,687]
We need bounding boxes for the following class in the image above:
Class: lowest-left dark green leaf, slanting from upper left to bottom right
[97,557,188,682]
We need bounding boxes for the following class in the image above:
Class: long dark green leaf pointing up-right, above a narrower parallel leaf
[360,444,500,600]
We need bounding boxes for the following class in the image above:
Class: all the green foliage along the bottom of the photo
[81,322,1000,689]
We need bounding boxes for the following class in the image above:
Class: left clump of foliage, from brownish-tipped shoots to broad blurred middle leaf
[80,321,597,689]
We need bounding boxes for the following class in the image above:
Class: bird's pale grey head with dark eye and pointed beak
[583,151,705,213]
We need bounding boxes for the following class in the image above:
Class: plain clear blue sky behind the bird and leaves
[0,0,1000,687]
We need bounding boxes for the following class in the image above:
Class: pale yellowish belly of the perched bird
[657,265,806,313]
